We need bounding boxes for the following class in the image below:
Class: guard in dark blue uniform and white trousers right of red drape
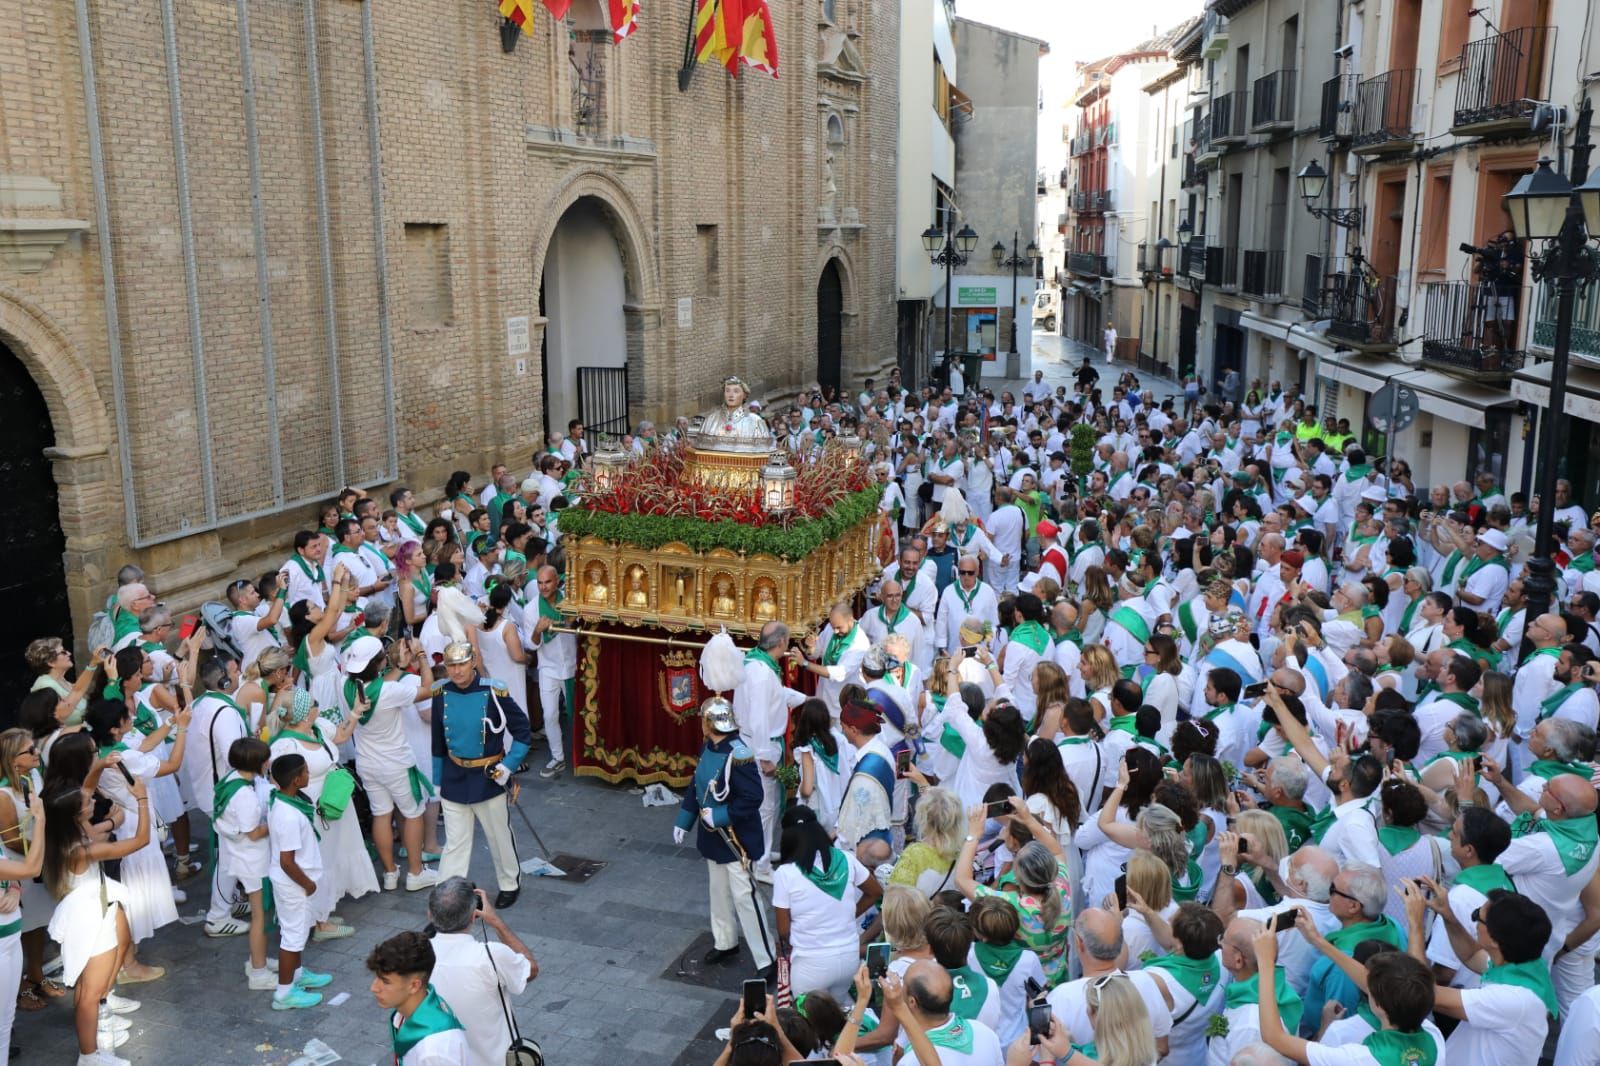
[672,696,774,976]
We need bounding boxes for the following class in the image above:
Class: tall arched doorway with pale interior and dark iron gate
[539,197,629,434]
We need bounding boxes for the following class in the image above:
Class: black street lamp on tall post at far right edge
[1502,108,1600,630]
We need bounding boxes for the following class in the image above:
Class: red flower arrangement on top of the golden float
[576,450,870,527]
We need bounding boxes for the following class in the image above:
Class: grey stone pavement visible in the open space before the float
[13,757,750,1066]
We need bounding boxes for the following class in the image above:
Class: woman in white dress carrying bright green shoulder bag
[272,691,368,940]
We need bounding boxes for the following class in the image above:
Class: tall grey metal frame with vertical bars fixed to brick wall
[75,0,398,546]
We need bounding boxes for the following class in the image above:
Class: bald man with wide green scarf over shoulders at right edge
[1483,771,1600,1008]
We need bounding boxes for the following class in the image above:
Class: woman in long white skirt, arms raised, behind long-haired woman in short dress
[86,699,190,984]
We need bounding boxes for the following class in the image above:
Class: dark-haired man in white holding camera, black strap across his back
[427,877,539,1063]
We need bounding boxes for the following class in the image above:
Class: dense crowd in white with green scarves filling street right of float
[694,360,1600,1066]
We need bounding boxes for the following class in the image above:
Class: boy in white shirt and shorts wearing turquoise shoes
[267,752,333,1010]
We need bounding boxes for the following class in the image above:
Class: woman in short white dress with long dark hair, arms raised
[42,754,148,1066]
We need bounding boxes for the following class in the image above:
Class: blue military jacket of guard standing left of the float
[432,677,533,804]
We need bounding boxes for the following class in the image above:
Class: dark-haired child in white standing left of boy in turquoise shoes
[211,736,278,991]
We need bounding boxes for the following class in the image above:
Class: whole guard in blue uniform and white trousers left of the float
[432,642,533,909]
